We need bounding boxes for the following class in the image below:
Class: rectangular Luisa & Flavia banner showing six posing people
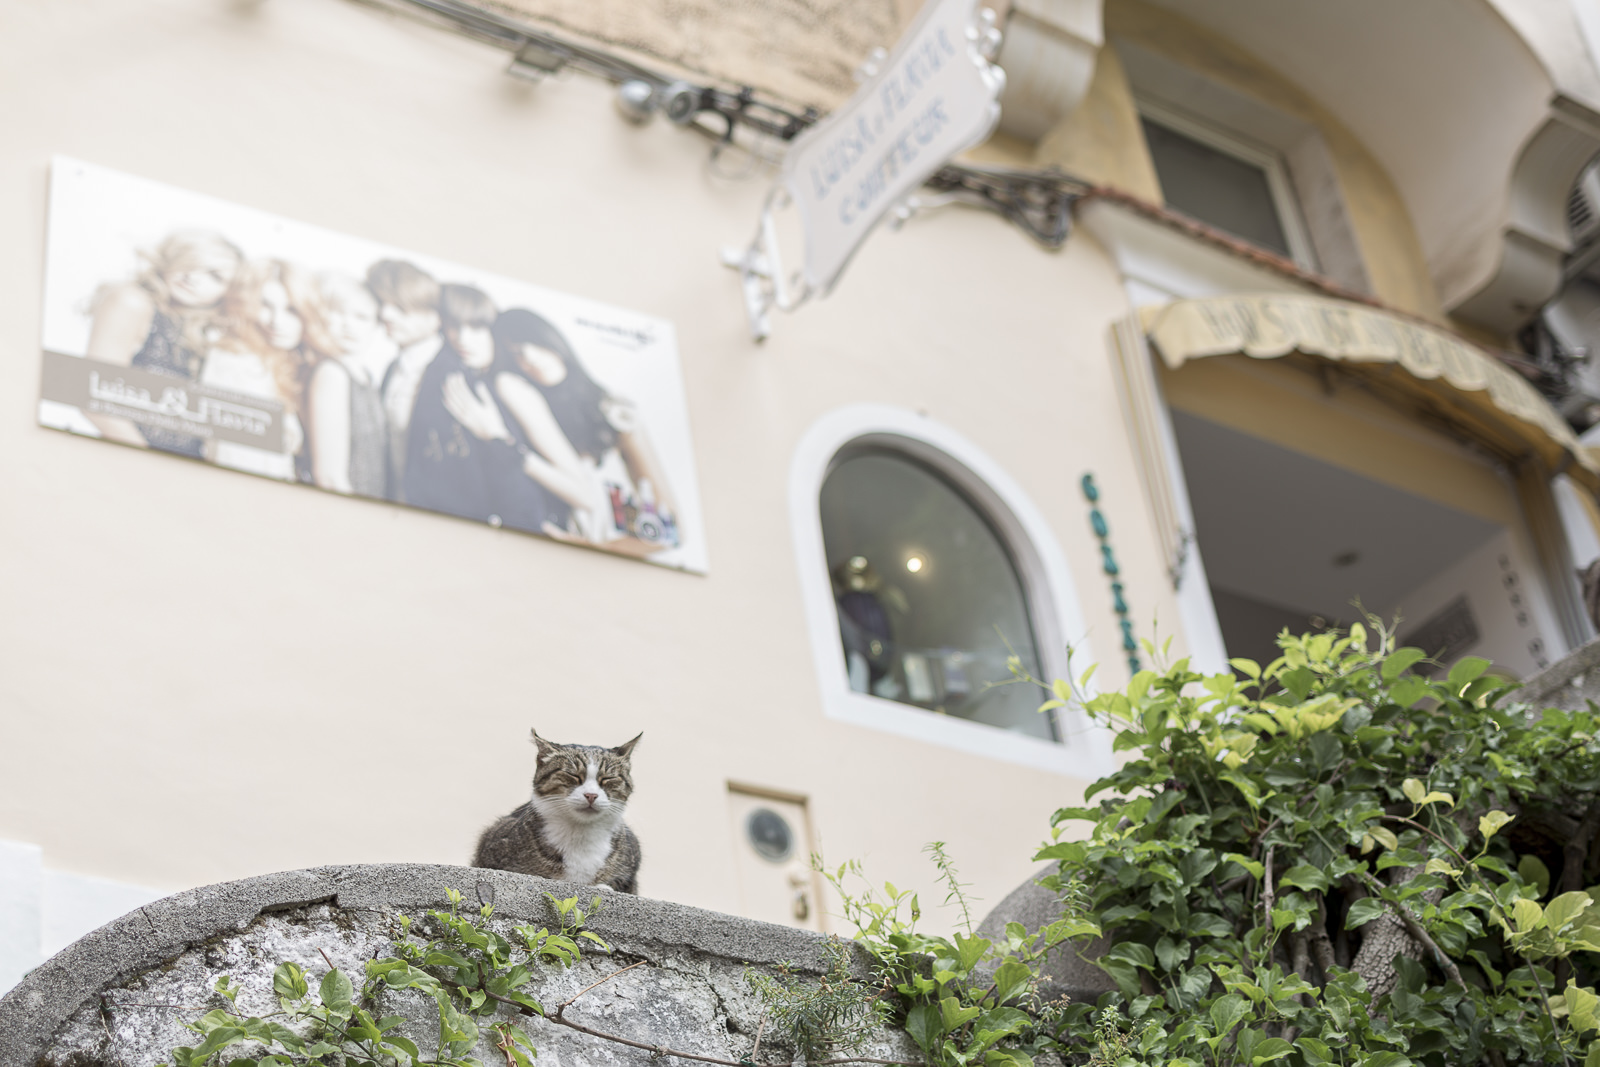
[38,158,706,573]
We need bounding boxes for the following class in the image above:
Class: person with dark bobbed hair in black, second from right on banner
[405,285,566,531]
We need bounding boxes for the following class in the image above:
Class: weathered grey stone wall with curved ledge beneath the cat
[0,864,917,1067]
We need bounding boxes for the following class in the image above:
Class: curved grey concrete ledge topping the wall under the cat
[0,864,859,1067]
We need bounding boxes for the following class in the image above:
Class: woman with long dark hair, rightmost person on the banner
[446,307,678,555]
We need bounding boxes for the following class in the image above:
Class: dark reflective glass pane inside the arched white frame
[821,451,1056,741]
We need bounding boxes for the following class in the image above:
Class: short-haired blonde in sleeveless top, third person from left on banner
[307,272,392,498]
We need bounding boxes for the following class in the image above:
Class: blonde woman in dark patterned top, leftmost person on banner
[83,230,245,458]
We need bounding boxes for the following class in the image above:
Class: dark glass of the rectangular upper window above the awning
[1141,118,1293,258]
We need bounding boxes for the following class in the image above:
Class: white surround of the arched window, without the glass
[789,405,1114,777]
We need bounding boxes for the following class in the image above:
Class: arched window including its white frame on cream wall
[789,405,1114,774]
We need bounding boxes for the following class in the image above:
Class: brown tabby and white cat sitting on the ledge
[472,729,645,894]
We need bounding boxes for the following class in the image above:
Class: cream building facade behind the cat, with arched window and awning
[0,0,1600,979]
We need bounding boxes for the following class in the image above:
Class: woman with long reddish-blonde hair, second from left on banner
[200,259,320,482]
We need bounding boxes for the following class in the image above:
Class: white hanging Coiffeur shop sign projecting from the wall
[726,0,1005,339]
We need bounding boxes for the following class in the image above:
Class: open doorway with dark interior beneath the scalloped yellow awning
[1171,410,1549,677]
